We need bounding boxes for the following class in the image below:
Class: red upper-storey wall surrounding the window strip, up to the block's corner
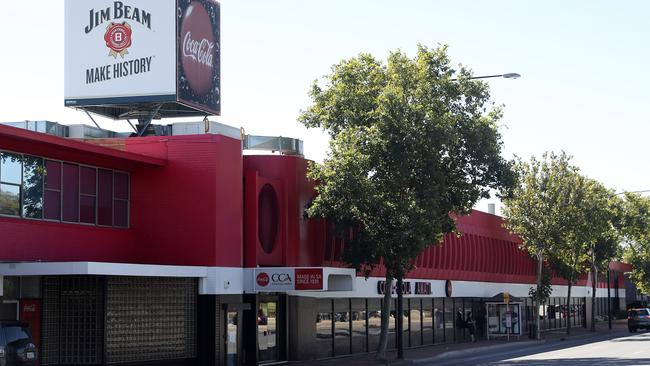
[0,130,243,267]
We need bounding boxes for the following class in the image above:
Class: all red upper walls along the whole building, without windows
[0,125,629,286]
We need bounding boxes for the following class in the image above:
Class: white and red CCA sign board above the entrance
[253,267,323,292]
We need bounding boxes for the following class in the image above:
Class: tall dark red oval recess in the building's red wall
[257,184,280,253]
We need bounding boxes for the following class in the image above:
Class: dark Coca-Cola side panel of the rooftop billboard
[177,0,220,114]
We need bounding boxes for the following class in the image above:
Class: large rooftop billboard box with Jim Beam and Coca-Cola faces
[65,0,221,117]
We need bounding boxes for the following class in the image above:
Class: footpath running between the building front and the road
[291,319,627,366]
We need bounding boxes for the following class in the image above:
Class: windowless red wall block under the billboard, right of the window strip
[125,134,243,267]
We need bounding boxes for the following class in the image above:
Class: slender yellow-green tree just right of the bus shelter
[503,152,579,339]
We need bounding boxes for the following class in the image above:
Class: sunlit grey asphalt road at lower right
[427,332,650,366]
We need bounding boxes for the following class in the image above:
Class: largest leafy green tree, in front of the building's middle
[299,46,513,358]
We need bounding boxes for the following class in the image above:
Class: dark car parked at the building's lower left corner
[0,321,38,366]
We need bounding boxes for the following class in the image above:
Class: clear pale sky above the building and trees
[0,0,650,209]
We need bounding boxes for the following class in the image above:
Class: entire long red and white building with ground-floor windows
[0,121,627,365]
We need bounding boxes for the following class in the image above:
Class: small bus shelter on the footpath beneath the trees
[485,292,522,339]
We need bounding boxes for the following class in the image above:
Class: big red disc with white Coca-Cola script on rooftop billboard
[180,1,218,96]
